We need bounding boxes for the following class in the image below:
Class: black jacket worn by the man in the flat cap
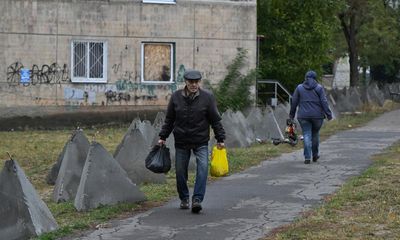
[159,89,225,148]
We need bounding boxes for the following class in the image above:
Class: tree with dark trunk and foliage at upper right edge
[338,0,400,86]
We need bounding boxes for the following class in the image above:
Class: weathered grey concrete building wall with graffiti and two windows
[0,0,257,127]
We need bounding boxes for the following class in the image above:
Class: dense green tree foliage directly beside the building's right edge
[257,0,340,90]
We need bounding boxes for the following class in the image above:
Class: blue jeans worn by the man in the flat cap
[175,145,208,201]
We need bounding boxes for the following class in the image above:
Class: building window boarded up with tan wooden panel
[141,43,174,83]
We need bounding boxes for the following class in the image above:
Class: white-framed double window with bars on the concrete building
[71,41,107,83]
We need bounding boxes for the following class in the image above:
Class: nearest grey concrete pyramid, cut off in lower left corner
[0,159,58,240]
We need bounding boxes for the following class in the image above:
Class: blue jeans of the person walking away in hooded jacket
[298,118,324,160]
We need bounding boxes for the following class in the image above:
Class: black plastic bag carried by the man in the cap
[145,145,171,173]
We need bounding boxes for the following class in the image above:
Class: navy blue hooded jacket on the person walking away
[289,71,332,120]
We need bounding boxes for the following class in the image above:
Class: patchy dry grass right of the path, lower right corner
[265,142,400,240]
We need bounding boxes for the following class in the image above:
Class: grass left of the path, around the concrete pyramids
[0,101,396,239]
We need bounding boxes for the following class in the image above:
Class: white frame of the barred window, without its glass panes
[71,40,108,83]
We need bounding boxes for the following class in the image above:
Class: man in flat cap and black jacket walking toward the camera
[158,70,225,213]
